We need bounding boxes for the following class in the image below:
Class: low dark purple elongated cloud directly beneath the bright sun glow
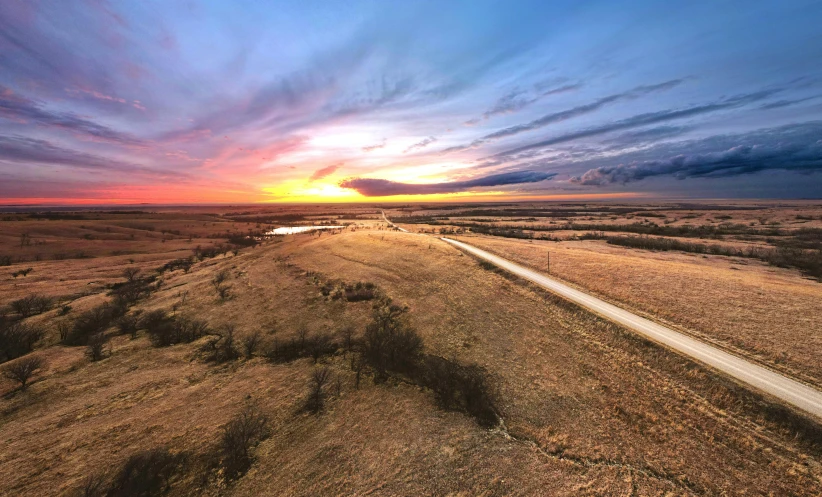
[340,171,556,197]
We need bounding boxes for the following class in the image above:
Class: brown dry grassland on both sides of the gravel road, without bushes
[0,203,822,495]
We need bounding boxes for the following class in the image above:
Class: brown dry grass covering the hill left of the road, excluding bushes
[0,204,822,495]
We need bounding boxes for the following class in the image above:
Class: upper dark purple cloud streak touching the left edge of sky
[0,86,144,147]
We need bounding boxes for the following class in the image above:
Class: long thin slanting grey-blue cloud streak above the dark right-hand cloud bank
[491,90,780,158]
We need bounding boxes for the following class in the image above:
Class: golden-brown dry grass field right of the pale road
[450,237,822,386]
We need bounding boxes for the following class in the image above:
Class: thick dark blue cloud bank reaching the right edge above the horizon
[571,122,822,186]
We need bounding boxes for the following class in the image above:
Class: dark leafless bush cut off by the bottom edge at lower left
[105,449,186,497]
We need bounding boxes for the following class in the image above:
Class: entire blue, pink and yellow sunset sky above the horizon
[0,0,822,205]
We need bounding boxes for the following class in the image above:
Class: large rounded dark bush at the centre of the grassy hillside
[362,300,422,382]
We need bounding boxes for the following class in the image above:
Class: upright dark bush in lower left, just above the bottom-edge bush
[217,407,268,479]
